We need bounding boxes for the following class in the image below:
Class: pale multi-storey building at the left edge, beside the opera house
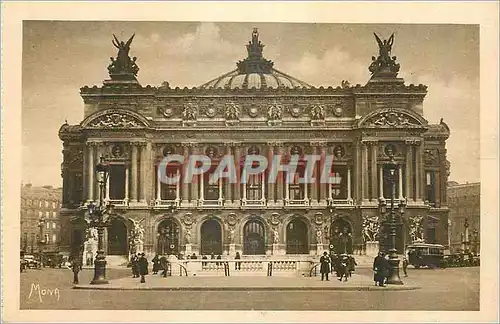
[20,184,62,254]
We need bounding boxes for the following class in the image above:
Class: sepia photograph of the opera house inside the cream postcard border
[2,4,498,321]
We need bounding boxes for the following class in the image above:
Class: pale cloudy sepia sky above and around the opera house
[22,21,480,186]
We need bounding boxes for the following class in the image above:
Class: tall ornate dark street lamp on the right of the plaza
[380,157,406,285]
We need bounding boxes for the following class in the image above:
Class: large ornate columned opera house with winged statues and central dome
[59,30,450,257]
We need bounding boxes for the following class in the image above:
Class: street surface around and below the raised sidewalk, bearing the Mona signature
[20,268,479,311]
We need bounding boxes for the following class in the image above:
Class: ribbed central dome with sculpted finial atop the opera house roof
[200,28,312,89]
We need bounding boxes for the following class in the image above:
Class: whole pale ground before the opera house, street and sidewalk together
[20,267,479,311]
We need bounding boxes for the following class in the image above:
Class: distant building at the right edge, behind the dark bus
[447,181,481,253]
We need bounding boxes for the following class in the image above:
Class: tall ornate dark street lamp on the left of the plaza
[87,156,113,285]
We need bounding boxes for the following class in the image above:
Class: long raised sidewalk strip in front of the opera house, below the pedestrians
[73,274,420,291]
